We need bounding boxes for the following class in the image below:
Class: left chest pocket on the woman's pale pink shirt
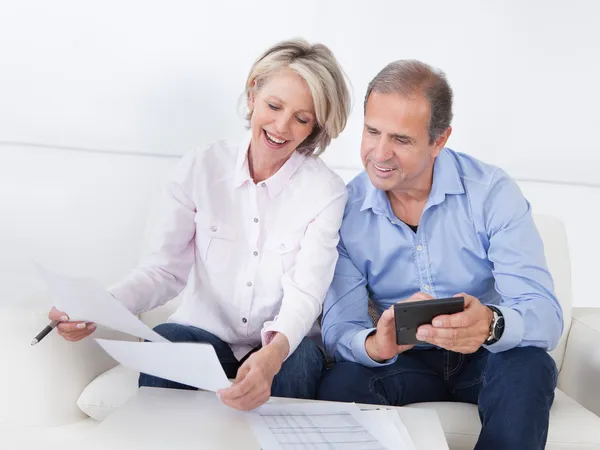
[194,214,237,273]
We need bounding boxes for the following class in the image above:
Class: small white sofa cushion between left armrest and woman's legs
[77,365,139,422]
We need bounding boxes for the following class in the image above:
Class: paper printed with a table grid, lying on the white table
[249,403,390,450]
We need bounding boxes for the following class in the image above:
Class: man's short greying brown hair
[364,59,452,144]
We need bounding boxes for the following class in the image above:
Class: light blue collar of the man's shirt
[360,148,465,217]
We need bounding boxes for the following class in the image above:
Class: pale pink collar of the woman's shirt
[233,132,307,198]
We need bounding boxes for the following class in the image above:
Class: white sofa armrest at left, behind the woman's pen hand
[0,294,136,426]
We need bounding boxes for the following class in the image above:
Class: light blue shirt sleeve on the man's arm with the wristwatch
[483,171,563,353]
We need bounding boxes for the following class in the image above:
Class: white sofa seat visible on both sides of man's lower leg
[411,389,600,450]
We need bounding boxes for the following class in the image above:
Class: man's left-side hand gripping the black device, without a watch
[365,292,433,362]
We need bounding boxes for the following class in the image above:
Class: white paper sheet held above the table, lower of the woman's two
[96,339,231,392]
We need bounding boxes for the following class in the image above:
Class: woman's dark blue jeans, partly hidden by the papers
[138,323,325,399]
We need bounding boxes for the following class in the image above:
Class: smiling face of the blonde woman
[248,70,316,164]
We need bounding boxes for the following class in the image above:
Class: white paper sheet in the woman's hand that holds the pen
[35,263,168,342]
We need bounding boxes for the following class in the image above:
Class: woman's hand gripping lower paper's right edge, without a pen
[217,333,290,411]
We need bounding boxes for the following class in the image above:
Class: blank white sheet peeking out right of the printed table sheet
[362,409,417,450]
